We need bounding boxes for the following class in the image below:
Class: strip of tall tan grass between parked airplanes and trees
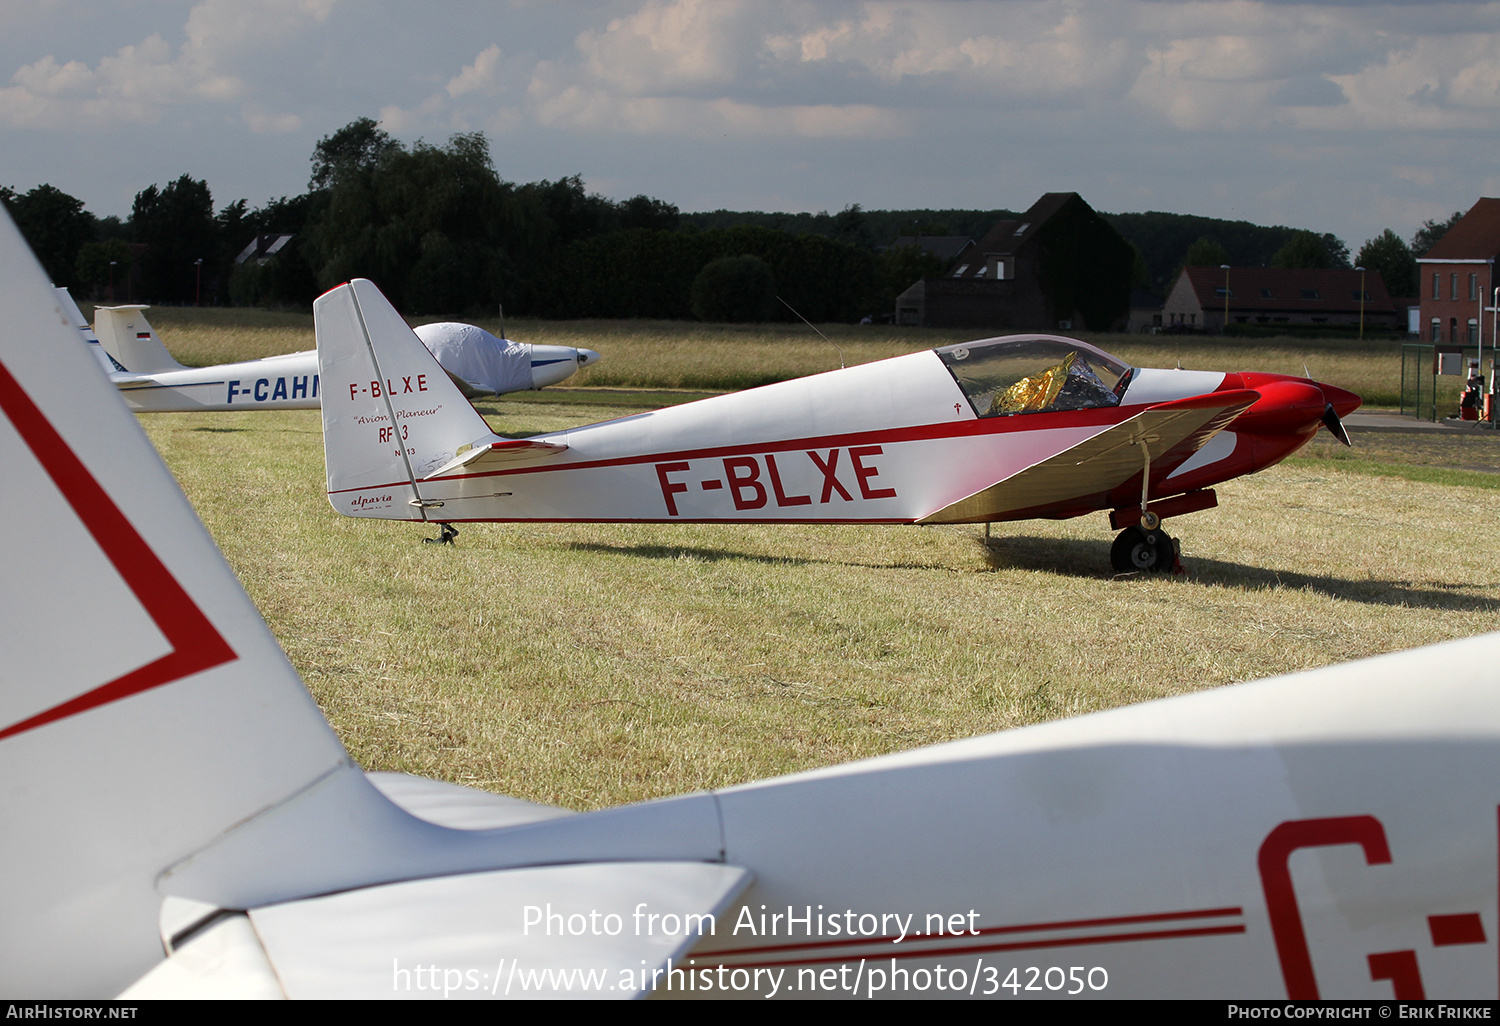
[135,306,1463,416]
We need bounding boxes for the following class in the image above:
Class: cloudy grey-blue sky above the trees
[0,0,1500,251]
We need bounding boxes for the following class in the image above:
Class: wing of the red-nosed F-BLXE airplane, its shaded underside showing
[918,389,1260,524]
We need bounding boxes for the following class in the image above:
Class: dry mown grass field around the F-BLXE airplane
[143,317,1500,809]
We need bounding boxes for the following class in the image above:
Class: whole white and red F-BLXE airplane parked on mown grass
[314,279,1359,570]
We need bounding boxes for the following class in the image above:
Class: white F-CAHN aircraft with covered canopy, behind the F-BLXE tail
[57,290,600,413]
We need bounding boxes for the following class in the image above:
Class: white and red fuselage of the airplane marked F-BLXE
[329,351,1358,524]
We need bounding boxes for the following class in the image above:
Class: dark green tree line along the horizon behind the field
[0,119,1458,321]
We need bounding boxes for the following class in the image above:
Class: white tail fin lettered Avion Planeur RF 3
[312,278,498,521]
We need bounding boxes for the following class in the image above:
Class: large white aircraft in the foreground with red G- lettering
[0,208,1500,999]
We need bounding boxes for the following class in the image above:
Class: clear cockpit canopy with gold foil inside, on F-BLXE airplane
[935,335,1136,417]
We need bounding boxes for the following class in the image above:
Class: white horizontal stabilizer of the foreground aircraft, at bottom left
[126,863,753,999]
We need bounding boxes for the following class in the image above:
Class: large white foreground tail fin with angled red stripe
[0,213,363,998]
